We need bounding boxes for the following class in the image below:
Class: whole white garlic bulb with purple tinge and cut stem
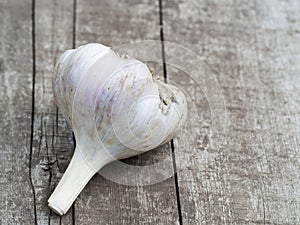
[48,44,187,215]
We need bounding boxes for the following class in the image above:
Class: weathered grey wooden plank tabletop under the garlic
[0,0,300,225]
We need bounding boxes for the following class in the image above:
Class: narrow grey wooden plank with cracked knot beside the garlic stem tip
[31,0,74,224]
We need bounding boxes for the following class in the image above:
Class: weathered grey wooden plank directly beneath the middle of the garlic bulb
[75,0,178,224]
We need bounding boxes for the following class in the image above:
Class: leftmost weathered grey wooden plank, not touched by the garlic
[0,0,35,225]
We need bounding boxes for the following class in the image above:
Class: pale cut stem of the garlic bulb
[48,147,106,215]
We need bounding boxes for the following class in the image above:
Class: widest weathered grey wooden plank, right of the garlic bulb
[163,0,300,224]
